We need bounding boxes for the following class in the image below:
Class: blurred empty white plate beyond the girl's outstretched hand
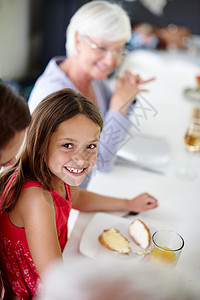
[117,134,170,167]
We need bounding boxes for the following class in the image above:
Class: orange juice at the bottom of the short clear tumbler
[150,248,177,265]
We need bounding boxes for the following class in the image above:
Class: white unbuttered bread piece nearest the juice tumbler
[129,219,151,249]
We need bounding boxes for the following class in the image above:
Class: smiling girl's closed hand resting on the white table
[127,193,158,213]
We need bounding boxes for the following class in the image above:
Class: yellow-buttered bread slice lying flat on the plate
[99,228,131,253]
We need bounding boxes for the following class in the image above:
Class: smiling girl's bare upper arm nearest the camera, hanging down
[18,187,62,277]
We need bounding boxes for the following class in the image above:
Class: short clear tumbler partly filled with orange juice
[150,229,184,267]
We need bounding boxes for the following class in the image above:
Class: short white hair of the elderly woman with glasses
[65,1,131,57]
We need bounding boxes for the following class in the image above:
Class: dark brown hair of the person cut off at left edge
[0,80,31,151]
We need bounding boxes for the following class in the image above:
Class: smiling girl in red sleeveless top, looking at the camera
[0,89,157,299]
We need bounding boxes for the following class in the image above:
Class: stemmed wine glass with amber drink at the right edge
[176,122,200,180]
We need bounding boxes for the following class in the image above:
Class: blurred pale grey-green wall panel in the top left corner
[0,0,30,78]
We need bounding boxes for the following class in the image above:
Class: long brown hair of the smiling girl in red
[0,88,103,211]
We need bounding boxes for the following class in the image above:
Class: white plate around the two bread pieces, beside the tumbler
[79,213,152,259]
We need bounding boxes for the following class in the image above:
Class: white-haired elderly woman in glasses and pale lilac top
[29,1,151,188]
